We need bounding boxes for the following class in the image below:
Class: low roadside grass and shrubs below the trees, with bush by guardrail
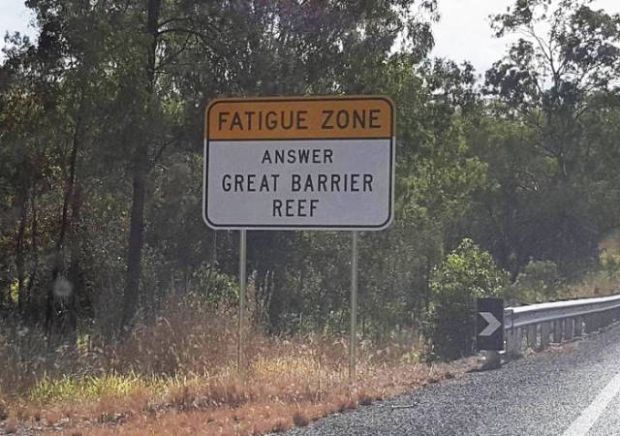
[0,240,620,435]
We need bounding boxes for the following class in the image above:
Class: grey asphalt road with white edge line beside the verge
[288,326,620,436]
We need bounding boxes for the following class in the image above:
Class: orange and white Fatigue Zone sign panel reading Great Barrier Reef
[203,97,395,230]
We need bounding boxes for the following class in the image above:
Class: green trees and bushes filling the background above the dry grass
[0,0,620,357]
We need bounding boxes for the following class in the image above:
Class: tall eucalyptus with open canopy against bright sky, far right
[486,0,620,271]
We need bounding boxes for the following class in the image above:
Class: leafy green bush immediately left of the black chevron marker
[426,239,508,359]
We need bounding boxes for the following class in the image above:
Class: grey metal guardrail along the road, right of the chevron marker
[504,295,620,356]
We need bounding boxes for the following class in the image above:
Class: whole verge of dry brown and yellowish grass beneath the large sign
[0,294,474,435]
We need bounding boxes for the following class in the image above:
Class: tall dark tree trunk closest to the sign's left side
[121,0,161,334]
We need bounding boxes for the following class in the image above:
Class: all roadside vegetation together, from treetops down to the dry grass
[0,0,620,434]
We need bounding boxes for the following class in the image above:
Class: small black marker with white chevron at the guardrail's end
[476,298,504,351]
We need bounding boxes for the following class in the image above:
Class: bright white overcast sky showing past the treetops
[0,0,620,73]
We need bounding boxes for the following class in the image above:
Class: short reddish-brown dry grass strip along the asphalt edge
[59,364,464,436]
